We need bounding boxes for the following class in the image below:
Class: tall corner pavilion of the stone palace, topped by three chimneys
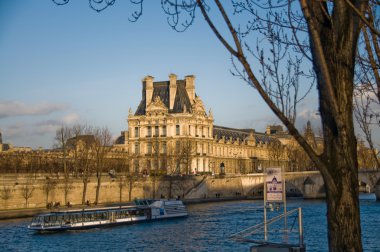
[128,74,213,174]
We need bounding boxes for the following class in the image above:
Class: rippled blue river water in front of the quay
[0,195,380,251]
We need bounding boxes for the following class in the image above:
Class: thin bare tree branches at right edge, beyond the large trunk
[354,1,380,169]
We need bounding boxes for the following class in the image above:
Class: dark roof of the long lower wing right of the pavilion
[213,125,278,144]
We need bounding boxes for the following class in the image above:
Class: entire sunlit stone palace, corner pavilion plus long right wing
[121,74,285,174]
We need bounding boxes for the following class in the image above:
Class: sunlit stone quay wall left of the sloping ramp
[0,174,203,210]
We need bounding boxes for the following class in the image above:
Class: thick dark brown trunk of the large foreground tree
[301,0,366,251]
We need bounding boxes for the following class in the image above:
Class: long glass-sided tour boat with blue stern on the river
[28,199,188,232]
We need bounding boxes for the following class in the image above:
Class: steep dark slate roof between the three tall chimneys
[135,80,192,115]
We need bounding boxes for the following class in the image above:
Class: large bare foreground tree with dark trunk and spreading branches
[53,0,380,251]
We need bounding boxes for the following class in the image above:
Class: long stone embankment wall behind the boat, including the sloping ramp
[0,174,255,211]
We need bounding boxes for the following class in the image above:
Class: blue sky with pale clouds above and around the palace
[0,0,324,148]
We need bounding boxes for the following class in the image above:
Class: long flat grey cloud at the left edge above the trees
[0,101,67,119]
